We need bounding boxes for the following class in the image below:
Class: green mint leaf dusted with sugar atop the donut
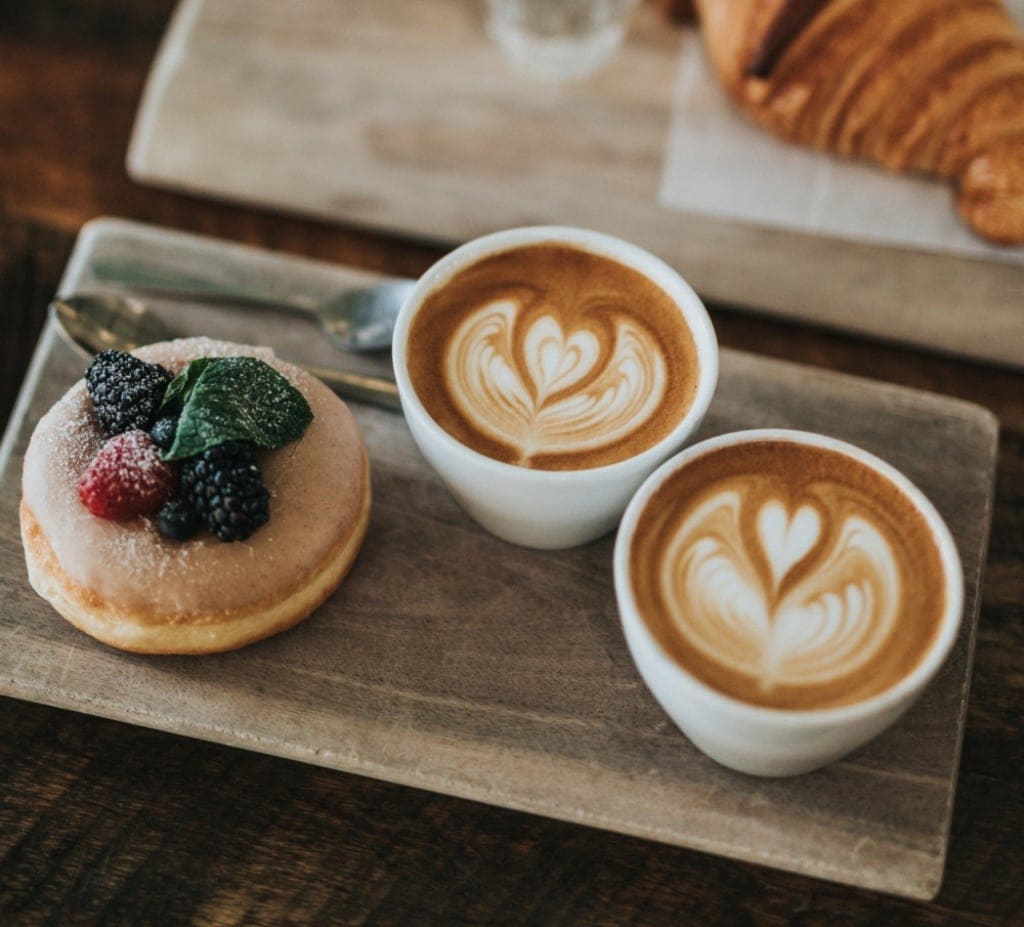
[161,357,313,460]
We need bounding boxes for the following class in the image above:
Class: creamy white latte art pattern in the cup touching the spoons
[445,300,666,463]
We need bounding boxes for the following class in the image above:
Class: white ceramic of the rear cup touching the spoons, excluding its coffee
[392,226,718,549]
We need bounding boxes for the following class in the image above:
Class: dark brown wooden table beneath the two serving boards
[0,0,1024,927]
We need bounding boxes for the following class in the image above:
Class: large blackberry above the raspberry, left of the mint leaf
[85,349,171,434]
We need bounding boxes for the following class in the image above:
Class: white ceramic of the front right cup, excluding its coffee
[614,429,964,776]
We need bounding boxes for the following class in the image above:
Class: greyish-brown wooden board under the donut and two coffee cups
[0,220,997,897]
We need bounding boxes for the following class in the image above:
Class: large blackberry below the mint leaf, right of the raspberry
[181,441,270,541]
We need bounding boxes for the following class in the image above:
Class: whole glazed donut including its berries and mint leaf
[20,338,370,654]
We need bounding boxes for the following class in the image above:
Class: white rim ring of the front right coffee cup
[612,428,964,728]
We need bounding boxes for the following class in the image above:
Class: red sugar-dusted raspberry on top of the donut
[78,429,176,520]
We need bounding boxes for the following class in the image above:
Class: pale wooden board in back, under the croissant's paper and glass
[128,0,1024,367]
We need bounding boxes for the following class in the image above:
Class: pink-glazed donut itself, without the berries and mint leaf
[20,338,371,654]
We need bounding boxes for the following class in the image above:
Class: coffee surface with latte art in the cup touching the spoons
[407,243,700,470]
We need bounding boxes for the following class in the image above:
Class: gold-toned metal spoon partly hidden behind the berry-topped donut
[50,293,401,409]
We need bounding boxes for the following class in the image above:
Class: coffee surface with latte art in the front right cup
[630,440,946,709]
